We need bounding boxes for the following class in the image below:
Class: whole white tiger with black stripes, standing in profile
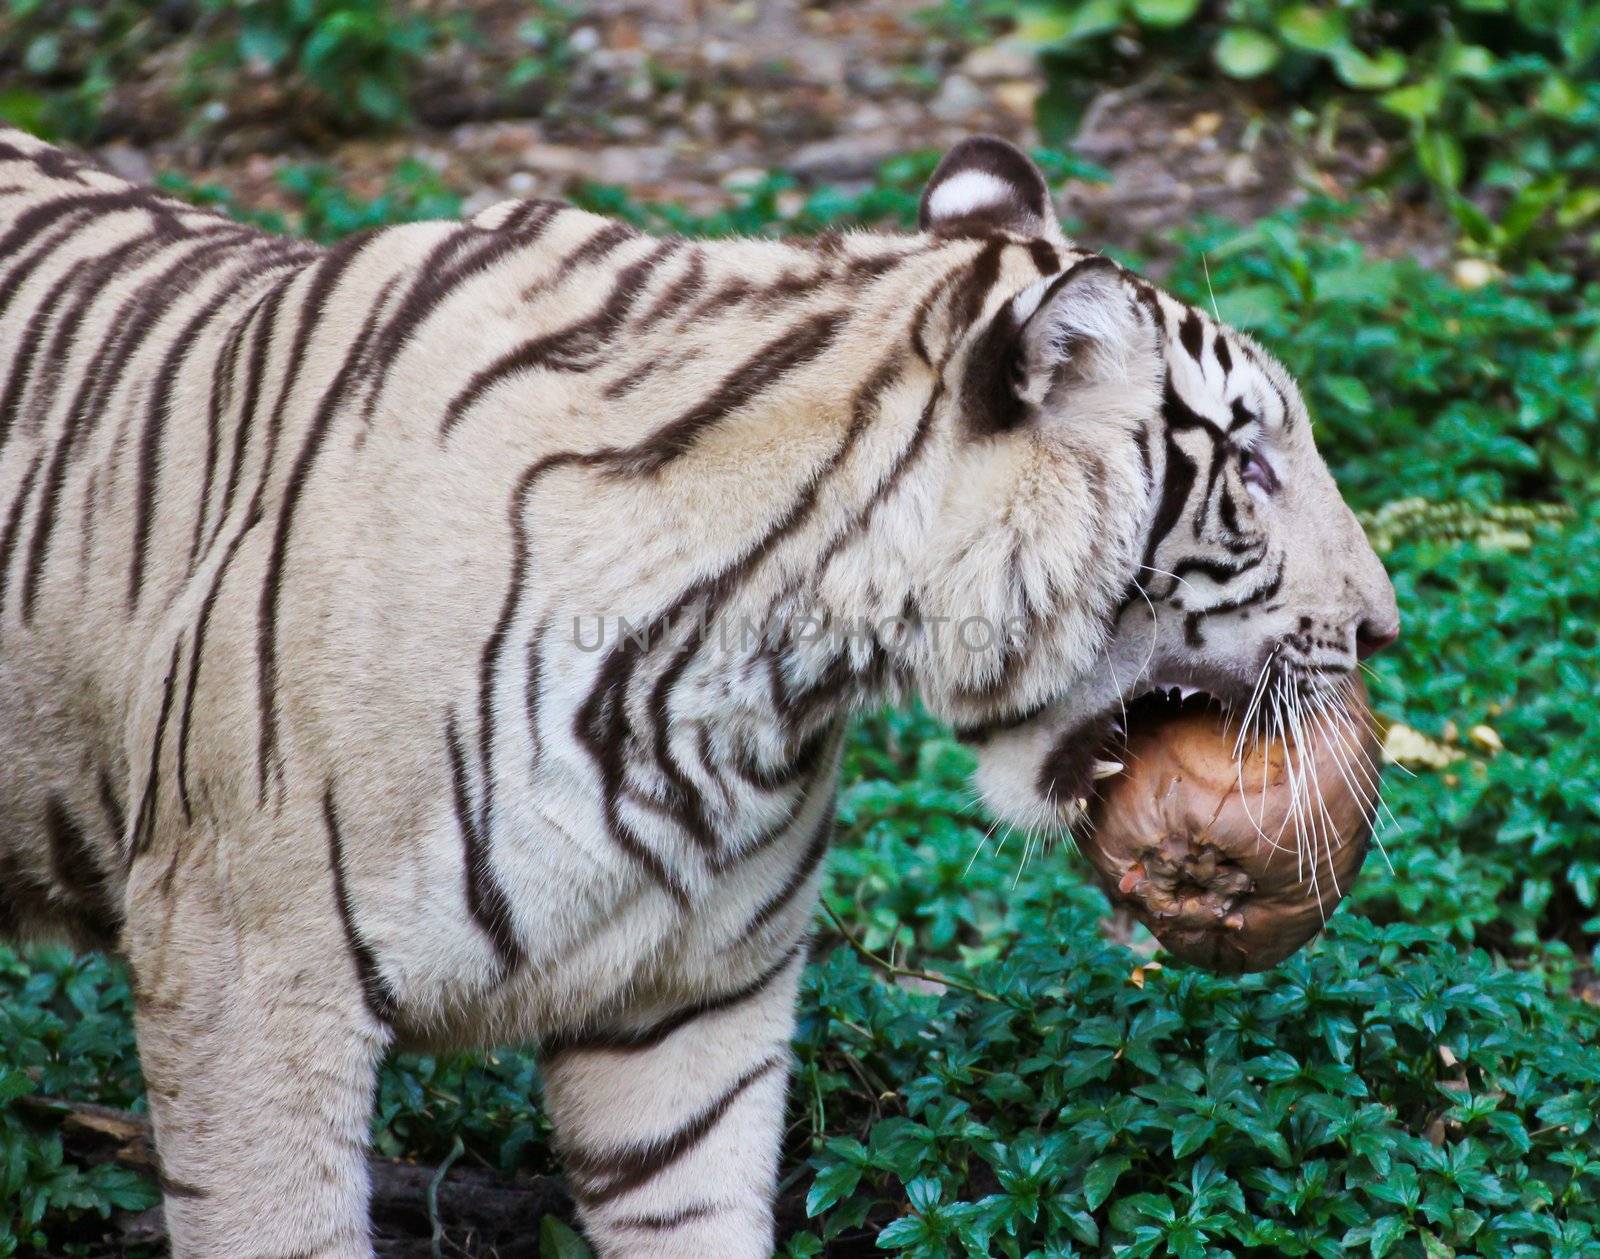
[0,131,1398,1259]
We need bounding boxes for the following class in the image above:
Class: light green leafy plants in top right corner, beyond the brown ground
[1004,0,1600,256]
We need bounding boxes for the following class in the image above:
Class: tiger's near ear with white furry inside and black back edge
[965,254,1162,432]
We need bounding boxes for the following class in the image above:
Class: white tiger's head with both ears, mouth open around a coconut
[917,138,1400,829]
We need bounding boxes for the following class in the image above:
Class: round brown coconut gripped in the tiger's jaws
[1078,689,1378,974]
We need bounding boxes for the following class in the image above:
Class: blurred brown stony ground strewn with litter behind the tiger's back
[84,0,1446,261]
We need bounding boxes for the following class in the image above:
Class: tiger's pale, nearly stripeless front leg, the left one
[123,831,390,1259]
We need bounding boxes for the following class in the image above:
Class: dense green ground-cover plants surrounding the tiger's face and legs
[0,91,1600,1259]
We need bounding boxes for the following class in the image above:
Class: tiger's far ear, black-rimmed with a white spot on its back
[917,136,1064,240]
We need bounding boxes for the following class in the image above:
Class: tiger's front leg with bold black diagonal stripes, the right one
[544,945,805,1259]
